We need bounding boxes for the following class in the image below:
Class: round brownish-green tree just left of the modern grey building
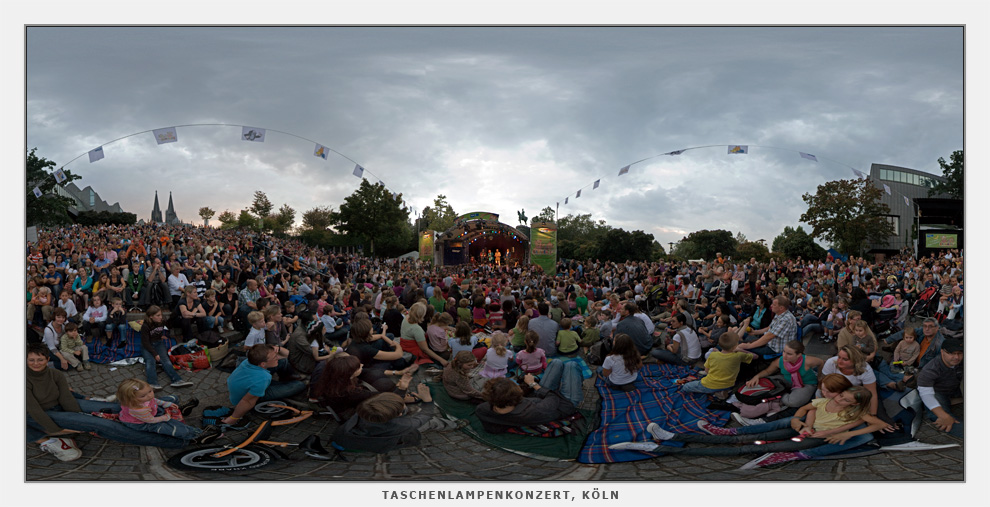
[800,179,894,255]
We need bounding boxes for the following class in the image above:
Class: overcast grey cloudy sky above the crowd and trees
[26,27,964,251]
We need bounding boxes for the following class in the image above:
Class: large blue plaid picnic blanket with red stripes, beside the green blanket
[578,364,729,463]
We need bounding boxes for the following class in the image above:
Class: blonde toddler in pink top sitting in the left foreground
[117,378,223,445]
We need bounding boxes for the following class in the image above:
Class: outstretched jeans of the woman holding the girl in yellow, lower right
[654,419,873,457]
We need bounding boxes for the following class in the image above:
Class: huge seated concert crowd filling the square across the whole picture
[26,224,964,470]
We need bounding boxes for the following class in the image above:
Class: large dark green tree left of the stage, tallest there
[336,179,415,256]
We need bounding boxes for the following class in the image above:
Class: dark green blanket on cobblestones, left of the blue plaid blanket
[427,382,598,461]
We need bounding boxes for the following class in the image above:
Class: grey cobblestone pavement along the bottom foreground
[26,356,964,481]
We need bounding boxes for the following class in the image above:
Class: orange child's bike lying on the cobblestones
[167,401,333,472]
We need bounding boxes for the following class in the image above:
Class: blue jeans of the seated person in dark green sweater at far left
[27,400,186,449]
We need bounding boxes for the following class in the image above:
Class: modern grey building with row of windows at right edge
[867,164,962,254]
